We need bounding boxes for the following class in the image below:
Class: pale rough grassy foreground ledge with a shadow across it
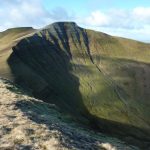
[0,79,138,150]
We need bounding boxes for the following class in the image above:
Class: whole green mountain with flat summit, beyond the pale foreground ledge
[0,22,150,147]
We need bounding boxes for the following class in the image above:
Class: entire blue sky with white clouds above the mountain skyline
[0,0,150,42]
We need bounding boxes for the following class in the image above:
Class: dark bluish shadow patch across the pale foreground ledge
[16,100,101,150]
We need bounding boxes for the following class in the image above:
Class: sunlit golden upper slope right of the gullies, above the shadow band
[87,30,150,63]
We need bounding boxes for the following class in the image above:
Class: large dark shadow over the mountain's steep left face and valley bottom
[8,31,149,149]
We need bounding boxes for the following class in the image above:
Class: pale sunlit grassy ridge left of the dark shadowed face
[0,27,35,78]
